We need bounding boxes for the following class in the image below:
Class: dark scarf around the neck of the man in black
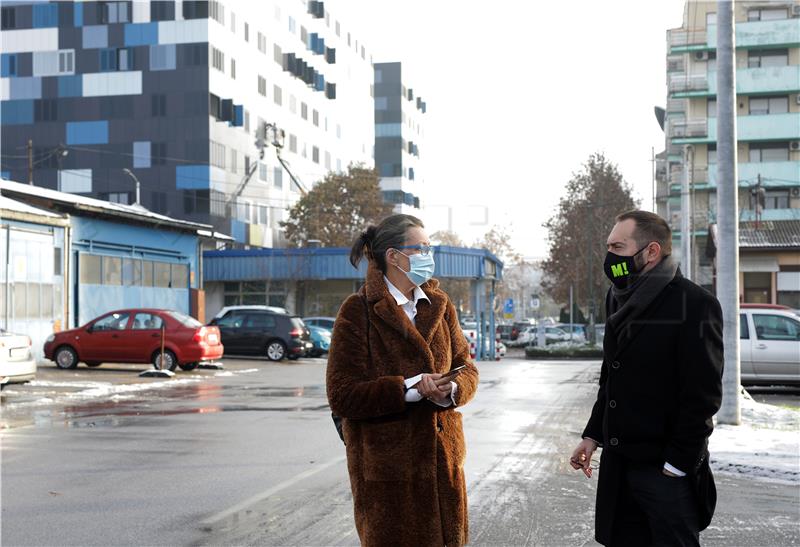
[606,256,681,345]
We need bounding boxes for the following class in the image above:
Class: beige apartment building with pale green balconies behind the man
[657,0,800,308]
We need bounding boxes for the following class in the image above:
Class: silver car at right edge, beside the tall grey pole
[739,304,800,384]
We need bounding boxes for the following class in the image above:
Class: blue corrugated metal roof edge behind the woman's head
[203,245,503,282]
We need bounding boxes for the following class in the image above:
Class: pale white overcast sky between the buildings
[332,0,684,257]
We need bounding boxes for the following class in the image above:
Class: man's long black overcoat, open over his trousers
[583,274,723,544]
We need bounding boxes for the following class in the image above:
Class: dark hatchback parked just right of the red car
[209,308,314,361]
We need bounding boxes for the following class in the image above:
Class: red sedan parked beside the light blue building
[44,309,223,370]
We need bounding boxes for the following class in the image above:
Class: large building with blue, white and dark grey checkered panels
[0,0,375,247]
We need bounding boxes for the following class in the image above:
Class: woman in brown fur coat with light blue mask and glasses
[327,215,478,547]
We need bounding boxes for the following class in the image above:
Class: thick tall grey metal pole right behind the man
[717,0,742,425]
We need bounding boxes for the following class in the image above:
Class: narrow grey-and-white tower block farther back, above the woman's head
[375,62,427,216]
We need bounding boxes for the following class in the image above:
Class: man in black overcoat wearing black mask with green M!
[570,211,723,546]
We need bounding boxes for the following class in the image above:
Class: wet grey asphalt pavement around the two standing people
[0,358,800,546]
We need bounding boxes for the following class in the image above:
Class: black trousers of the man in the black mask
[610,461,700,547]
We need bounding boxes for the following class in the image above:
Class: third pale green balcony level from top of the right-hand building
[672,112,800,144]
